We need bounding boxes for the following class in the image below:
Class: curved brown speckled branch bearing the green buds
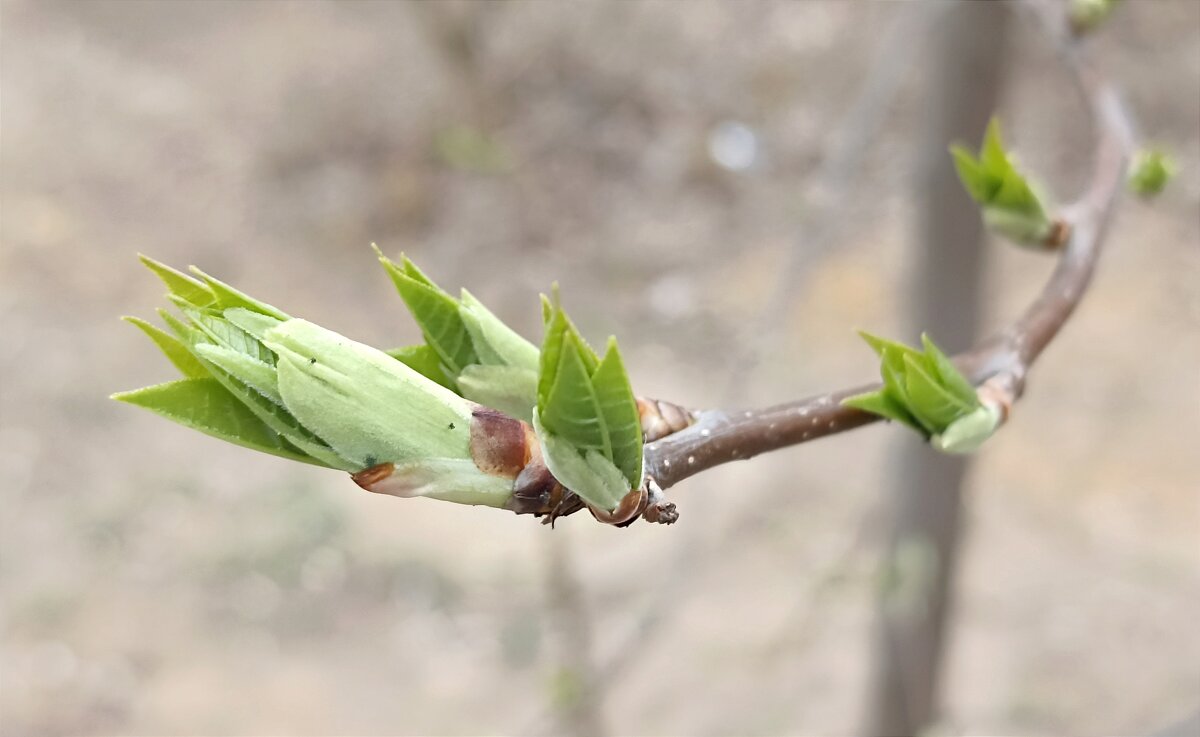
[646,5,1133,489]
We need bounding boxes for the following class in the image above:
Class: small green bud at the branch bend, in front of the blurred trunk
[842,332,998,453]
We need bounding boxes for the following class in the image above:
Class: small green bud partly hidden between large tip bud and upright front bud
[376,247,539,421]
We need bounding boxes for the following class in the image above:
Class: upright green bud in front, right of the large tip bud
[534,295,642,509]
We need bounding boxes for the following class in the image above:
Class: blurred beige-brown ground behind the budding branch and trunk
[0,0,1200,736]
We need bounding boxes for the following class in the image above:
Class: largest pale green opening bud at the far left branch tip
[113,257,511,505]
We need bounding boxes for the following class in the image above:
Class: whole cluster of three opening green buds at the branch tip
[114,248,642,510]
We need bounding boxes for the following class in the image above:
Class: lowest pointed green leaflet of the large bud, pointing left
[113,378,314,463]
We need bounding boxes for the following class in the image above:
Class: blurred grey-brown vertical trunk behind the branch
[866,2,1010,737]
